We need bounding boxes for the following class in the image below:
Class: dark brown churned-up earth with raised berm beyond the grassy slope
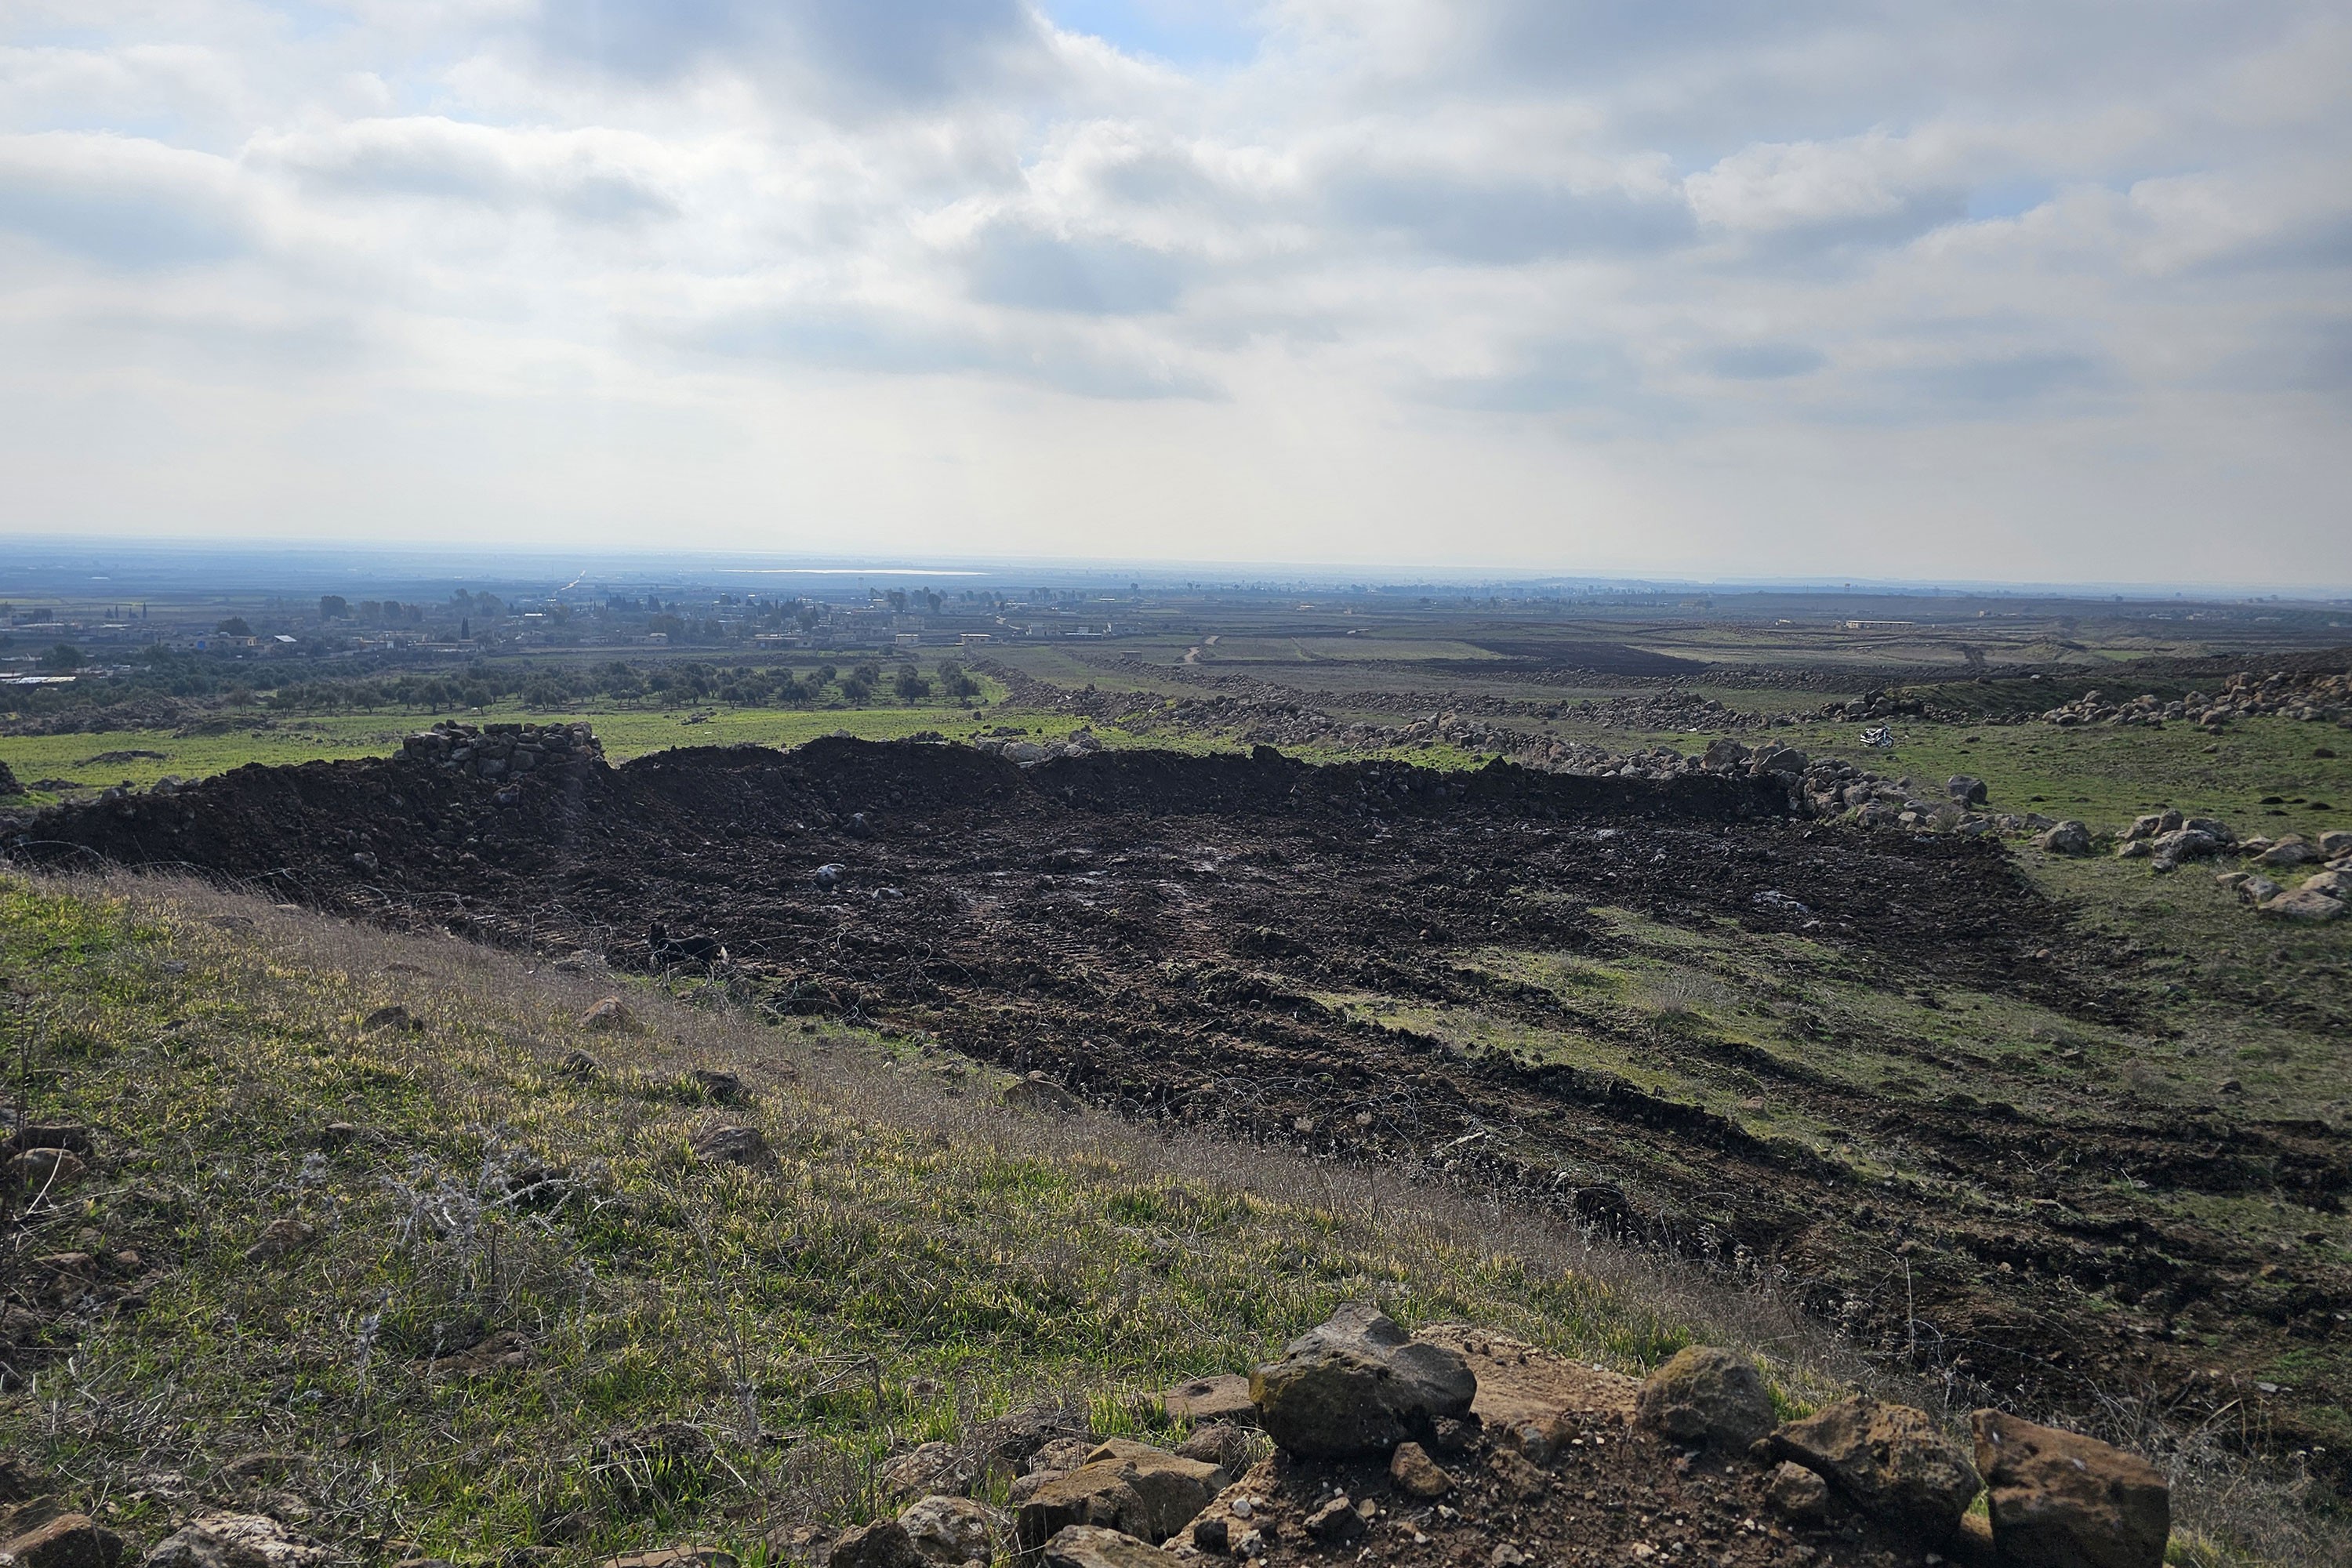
[0,727,2352,1486]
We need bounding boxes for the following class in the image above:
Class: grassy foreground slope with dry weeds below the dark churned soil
[0,877,1828,1561]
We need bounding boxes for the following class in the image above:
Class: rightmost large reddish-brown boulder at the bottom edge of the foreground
[1973,1410,2173,1568]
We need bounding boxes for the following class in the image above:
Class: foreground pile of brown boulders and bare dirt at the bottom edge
[837,1307,2171,1568]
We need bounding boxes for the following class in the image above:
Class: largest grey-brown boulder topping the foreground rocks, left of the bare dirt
[1249,1305,1477,1457]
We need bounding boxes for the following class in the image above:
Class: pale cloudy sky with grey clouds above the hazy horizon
[0,0,2352,590]
